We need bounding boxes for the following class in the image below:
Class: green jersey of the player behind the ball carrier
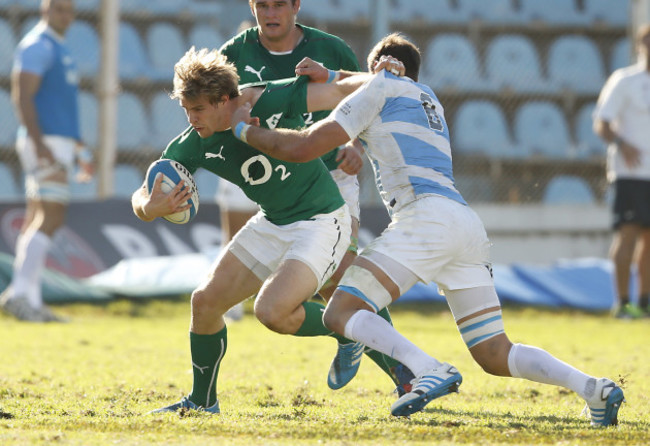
[219,25,361,170]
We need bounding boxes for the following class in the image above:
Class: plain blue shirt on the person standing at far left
[13,22,80,140]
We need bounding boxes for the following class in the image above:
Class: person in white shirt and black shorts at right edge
[594,25,650,318]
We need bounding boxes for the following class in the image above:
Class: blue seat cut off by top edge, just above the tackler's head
[388,0,465,23]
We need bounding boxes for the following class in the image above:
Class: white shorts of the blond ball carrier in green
[228,205,351,292]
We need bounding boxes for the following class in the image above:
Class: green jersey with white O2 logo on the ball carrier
[162,77,344,225]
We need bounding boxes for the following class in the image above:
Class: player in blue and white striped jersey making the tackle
[231,34,624,427]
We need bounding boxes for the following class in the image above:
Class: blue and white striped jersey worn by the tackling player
[331,70,467,212]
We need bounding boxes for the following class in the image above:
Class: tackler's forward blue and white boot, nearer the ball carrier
[390,362,463,417]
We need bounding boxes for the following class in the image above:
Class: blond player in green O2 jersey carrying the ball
[132,48,404,413]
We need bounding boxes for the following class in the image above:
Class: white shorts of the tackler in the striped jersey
[360,195,493,292]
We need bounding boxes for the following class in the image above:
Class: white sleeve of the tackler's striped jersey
[330,75,386,139]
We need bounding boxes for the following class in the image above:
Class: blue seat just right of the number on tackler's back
[452,100,518,158]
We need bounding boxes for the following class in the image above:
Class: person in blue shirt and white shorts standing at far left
[0,0,92,322]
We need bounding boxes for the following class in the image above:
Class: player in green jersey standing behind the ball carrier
[217,0,413,393]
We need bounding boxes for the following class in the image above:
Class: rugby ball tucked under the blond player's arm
[146,159,199,225]
